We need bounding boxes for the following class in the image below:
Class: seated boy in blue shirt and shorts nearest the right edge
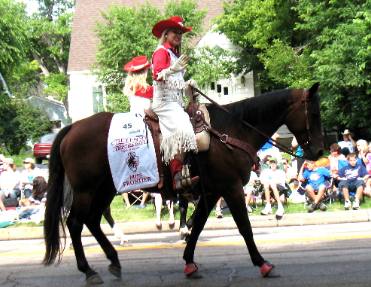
[337,153,368,210]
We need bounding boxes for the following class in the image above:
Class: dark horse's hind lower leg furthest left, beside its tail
[67,215,103,284]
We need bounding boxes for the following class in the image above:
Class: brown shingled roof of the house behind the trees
[68,0,223,72]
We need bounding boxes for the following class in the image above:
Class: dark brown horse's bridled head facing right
[286,83,324,160]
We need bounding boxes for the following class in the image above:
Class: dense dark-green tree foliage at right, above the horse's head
[218,0,371,133]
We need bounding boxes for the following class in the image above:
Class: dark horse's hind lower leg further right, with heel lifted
[86,217,121,278]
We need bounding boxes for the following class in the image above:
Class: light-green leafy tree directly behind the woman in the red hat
[99,0,237,111]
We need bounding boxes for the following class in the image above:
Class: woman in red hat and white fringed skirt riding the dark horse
[152,16,199,190]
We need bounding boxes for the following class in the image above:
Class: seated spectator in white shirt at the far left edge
[0,158,21,211]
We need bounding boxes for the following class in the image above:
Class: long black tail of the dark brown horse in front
[43,125,71,265]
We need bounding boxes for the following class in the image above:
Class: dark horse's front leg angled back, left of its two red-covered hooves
[183,194,219,277]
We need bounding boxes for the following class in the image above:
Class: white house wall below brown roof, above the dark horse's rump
[68,71,105,122]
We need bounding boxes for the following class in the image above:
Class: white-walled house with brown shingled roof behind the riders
[68,0,255,122]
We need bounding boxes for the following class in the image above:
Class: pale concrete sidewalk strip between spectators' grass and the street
[0,209,371,240]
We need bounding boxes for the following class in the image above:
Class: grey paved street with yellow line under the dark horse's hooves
[0,223,371,287]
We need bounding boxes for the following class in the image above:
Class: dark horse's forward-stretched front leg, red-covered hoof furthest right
[222,187,274,277]
